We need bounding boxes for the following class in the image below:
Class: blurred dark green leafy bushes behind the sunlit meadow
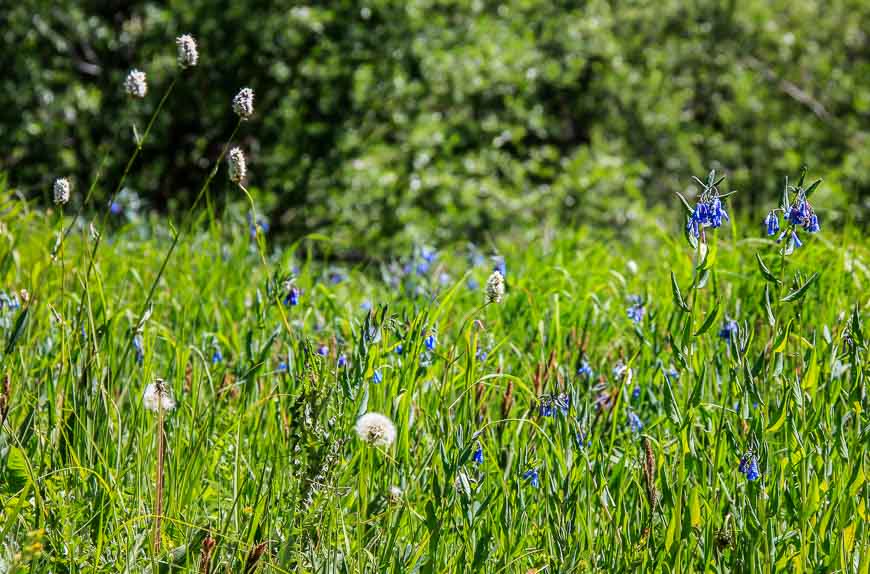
[0,0,870,247]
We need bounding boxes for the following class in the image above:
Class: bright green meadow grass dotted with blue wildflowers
[0,181,870,574]
